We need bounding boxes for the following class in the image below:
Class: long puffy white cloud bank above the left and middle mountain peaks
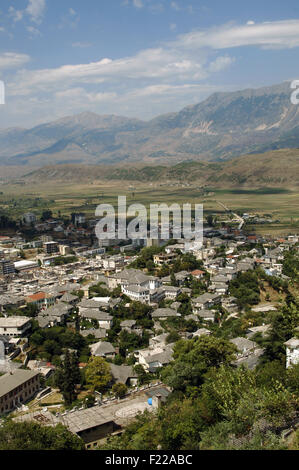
[11,48,206,95]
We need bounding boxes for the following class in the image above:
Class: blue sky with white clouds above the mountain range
[0,0,299,128]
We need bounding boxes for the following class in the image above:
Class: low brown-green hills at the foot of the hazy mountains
[23,149,299,188]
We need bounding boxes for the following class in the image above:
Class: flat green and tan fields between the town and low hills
[0,181,299,235]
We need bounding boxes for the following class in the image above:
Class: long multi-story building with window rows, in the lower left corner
[0,369,40,415]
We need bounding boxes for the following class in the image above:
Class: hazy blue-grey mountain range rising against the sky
[0,82,299,167]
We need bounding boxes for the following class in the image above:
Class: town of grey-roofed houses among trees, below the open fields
[0,207,299,449]
